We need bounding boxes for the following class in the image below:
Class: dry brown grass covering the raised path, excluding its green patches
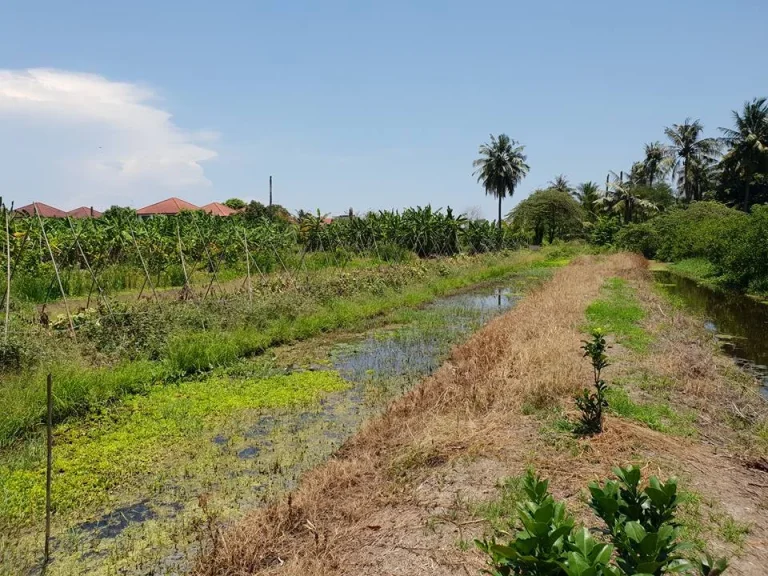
[196,255,768,576]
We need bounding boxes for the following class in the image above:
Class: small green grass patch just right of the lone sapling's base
[606,386,696,436]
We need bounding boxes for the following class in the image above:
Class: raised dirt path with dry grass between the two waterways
[198,255,768,576]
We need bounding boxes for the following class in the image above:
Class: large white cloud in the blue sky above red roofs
[0,69,216,208]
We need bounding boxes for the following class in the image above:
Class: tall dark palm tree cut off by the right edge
[720,98,768,212]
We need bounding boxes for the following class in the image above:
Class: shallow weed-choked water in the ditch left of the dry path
[42,277,539,574]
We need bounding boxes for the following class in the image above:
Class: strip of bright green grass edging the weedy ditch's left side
[0,251,566,448]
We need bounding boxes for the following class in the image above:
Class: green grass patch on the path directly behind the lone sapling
[586,278,651,352]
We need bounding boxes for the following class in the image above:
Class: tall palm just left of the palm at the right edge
[664,118,720,200]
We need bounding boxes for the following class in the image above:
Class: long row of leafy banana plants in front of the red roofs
[0,205,523,302]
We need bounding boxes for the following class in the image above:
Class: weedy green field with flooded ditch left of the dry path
[0,235,570,574]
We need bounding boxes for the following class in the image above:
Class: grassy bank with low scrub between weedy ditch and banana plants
[0,251,559,447]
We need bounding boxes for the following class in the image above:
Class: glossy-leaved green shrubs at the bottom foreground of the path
[475,466,727,576]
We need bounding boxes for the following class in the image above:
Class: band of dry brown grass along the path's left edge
[198,256,635,574]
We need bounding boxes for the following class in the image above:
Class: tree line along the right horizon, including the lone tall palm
[474,98,768,244]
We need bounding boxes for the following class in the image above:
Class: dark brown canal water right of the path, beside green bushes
[655,271,768,393]
